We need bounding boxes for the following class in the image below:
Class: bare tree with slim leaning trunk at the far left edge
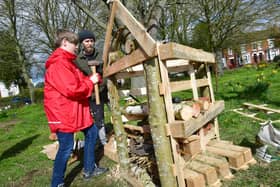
[0,0,35,102]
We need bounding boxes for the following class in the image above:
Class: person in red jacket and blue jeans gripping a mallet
[44,30,107,187]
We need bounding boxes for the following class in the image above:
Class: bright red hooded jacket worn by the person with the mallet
[44,48,93,132]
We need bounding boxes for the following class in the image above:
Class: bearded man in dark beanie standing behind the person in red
[75,30,108,146]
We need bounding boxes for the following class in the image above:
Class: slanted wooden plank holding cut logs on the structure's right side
[169,101,225,138]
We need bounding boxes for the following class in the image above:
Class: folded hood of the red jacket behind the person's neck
[46,48,77,69]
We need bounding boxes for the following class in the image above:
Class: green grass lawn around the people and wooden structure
[0,62,280,187]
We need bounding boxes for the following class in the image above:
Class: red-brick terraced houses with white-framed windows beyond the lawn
[223,31,280,69]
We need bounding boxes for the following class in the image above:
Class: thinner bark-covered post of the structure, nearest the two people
[107,77,129,173]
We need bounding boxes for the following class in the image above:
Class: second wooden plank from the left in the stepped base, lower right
[186,161,219,185]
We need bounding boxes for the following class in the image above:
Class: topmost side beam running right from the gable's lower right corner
[159,42,215,63]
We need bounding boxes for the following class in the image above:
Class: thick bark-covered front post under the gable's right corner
[144,58,177,187]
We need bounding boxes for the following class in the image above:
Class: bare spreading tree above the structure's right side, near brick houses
[161,0,279,74]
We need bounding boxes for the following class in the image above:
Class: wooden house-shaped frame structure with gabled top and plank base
[103,0,254,187]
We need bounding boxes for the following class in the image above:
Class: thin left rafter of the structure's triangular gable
[102,1,117,68]
